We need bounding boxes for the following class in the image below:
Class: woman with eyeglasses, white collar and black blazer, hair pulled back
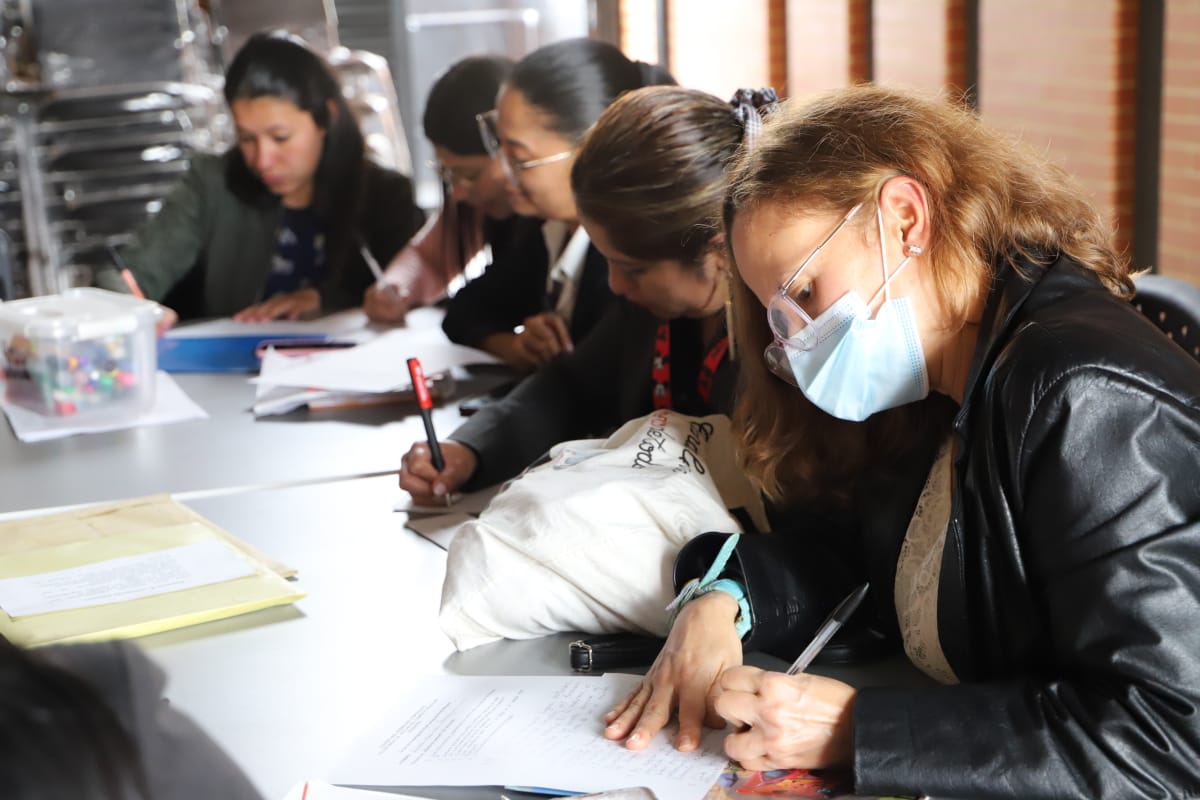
[443,40,673,371]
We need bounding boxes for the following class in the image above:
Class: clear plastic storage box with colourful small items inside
[0,289,162,420]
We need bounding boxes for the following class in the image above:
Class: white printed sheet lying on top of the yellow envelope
[0,541,254,618]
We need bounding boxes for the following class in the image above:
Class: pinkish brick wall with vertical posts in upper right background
[626,0,1200,284]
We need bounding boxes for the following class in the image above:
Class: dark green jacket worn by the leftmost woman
[97,155,425,318]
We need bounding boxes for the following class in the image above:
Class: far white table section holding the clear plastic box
[0,369,504,516]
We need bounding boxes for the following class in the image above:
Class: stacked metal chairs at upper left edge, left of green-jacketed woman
[0,0,230,296]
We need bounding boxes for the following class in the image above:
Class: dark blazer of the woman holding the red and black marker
[450,299,736,489]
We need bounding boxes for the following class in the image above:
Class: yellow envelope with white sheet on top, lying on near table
[0,495,305,646]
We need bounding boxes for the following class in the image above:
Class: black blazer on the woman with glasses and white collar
[442,224,612,348]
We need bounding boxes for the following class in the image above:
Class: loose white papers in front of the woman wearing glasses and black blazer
[252,327,497,392]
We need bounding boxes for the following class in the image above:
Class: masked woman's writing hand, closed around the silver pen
[714,667,856,770]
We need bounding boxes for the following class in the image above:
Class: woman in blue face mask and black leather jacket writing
[608,86,1200,800]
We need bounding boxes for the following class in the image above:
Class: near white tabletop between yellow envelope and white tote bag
[140,476,458,800]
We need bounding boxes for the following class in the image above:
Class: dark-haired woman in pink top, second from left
[362,55,540,323]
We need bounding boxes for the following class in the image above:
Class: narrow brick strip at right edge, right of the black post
[1158,0,1200,285]
